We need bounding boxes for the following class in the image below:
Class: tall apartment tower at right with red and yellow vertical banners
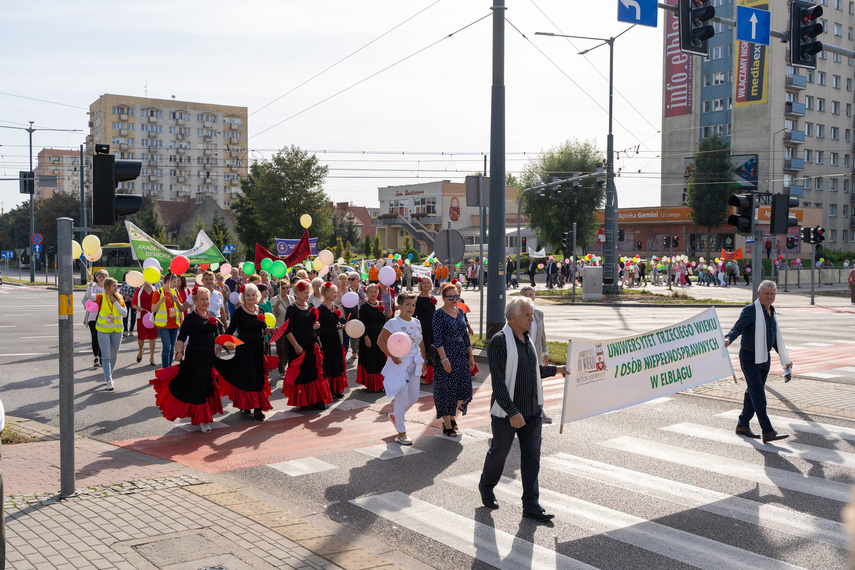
[661,0,855,250]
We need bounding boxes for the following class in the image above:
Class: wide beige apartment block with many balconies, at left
[87,94,249,208]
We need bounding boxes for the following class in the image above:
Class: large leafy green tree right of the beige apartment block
[232,146,332,251]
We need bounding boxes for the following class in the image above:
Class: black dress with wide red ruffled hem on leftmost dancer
[149,311,223,425]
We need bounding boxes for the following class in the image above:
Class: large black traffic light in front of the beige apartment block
[92,144,142,226]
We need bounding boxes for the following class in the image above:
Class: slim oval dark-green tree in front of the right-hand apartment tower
[686,135,737,257]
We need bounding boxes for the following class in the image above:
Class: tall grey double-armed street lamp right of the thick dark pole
[535,25,635,287]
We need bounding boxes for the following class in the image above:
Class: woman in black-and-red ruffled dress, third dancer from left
[282,279,332,410]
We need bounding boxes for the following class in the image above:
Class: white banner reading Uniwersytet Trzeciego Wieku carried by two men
[561,308,733,424]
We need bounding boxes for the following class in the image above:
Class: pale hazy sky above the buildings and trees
[0,0,664,211]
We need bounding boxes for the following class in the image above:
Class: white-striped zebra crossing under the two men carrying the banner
[338,410,855,570]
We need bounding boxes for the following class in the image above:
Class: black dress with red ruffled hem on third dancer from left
[282,305,332,406]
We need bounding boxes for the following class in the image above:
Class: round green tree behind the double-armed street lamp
[518,140,605,249]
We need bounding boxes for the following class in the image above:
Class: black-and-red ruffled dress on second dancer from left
[216,306,278,411]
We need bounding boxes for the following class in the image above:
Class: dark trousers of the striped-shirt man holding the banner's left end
[481,411,543,510]
